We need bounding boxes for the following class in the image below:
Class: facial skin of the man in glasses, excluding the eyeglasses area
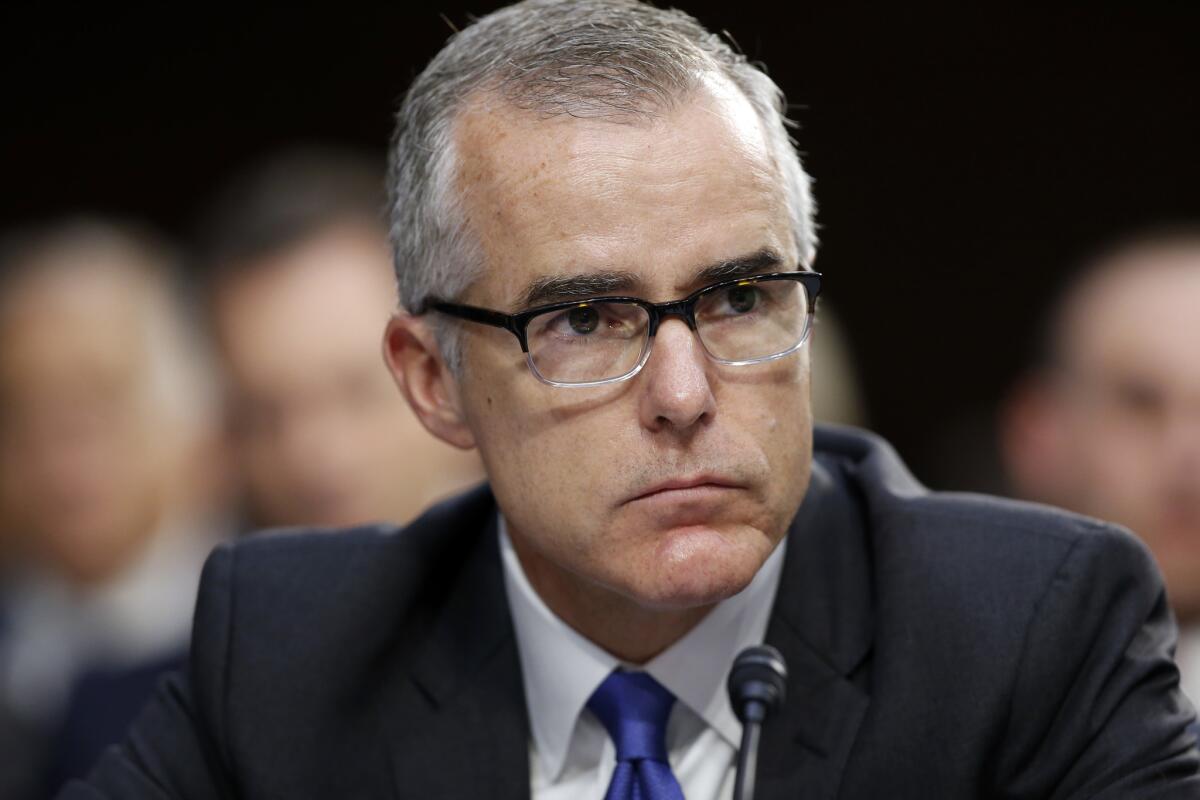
[446,82,811,608]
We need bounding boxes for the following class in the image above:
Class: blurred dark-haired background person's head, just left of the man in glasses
[200,149,482,527]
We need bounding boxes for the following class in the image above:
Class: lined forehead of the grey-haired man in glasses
[456,78,794,300]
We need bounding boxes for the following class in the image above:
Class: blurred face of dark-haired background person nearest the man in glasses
[214,224,479,525]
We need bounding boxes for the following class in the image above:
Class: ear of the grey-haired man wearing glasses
[383,312,475,450]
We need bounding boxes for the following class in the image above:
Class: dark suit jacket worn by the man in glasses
[66,429,1200,800]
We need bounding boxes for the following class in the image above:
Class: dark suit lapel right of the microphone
[756,461,871,800]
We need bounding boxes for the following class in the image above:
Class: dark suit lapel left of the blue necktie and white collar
[383,506,529,800]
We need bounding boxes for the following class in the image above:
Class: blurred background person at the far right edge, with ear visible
[1001,228,1200,700]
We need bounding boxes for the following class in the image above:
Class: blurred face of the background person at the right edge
[1060,249,1200,618]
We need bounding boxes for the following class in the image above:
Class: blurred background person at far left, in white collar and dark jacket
[0,222,221,799]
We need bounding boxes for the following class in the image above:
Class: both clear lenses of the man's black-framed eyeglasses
[526,279,809,384]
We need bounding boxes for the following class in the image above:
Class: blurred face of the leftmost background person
[0,261,182,582]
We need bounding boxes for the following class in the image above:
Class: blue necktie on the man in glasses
[588,669,684,800]
